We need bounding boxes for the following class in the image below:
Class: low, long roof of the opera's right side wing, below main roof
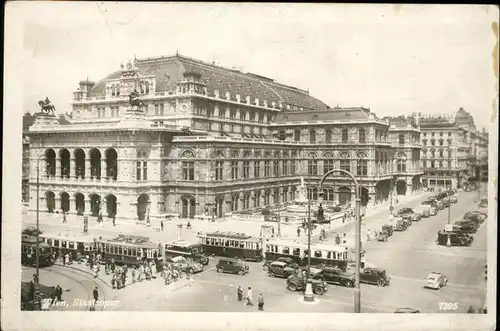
[273,107,377,123]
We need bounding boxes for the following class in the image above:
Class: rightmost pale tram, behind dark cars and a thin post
[265,240,348,271]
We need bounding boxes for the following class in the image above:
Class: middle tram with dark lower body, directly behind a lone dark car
[197,231,262,262]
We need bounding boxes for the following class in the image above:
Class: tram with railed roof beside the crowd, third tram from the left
[95,234,162,265]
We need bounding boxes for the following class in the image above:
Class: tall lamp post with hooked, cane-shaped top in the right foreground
[318,169,361,313]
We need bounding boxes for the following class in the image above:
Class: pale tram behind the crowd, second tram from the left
[40,233,96,261]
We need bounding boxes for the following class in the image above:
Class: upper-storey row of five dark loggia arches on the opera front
[44,148,118,180]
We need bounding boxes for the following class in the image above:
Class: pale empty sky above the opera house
[7,2,498,132]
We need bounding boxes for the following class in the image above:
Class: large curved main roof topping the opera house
[90,55,327,110]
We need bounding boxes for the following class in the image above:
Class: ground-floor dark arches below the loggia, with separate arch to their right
[45,191,150,220]
